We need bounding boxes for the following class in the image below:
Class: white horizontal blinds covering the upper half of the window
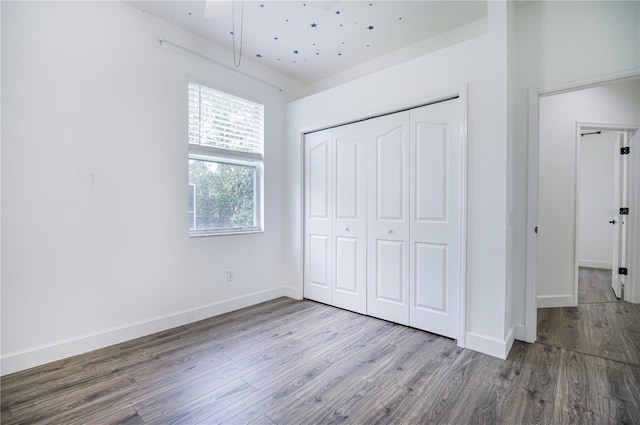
[189,83,264,158]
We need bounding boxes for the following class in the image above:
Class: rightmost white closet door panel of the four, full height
[410,100,462,338]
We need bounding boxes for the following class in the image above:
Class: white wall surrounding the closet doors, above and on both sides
[287,2,511,357]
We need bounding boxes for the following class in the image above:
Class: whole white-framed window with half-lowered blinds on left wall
[188,83,264,236]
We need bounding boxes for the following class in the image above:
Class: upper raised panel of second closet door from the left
[335,139,360,220]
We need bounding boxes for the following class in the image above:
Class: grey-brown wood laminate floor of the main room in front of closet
[0,298,640,425]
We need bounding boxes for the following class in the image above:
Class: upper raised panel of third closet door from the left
[376,127,405,220]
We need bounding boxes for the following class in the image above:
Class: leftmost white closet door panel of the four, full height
[304,130,334,304]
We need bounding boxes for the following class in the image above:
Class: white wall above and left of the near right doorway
[510,1,640,324]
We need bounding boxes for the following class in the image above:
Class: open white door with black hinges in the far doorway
[611,132,629,298]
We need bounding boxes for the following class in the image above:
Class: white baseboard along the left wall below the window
[0,287,295,376]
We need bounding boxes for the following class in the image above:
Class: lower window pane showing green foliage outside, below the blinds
[189,159,257,230]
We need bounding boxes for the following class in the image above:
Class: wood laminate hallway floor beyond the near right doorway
[537,267,640,362]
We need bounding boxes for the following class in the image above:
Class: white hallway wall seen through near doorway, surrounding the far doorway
[538,79,640,307]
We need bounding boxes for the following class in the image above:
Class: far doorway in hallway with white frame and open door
[573,123,638,305]
